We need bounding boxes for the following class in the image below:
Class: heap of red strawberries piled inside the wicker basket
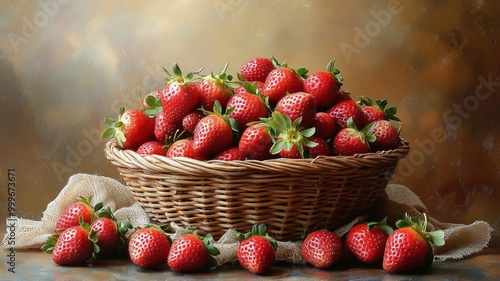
[101,57,402,161]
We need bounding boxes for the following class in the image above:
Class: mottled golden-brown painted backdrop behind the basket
[0,0,500,228]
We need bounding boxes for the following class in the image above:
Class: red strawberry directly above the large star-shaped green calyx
[275,92,316,128]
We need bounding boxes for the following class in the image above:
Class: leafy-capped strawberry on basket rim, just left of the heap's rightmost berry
[333,118,375,156]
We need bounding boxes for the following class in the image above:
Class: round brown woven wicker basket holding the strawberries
[105,140,410,241]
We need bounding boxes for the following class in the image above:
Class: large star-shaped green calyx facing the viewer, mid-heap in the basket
[261,111,318,158]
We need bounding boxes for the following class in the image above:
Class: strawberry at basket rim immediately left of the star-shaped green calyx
[238,123,274,160]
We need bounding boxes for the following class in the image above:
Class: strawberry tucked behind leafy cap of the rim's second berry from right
[327,100,365,131]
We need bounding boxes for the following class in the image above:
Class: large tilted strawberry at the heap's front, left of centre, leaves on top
[193,101,236,155]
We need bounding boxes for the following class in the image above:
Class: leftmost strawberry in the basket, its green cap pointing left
[101,107,155,150]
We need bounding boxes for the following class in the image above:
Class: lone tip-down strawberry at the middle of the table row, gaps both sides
[237,224,278,274]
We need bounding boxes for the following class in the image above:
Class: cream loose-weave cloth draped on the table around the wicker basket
[3,174,492,264]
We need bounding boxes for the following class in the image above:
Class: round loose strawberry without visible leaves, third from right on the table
[301,229,343,269]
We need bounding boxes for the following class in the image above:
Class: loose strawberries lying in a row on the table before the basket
[42,198,444,274]
